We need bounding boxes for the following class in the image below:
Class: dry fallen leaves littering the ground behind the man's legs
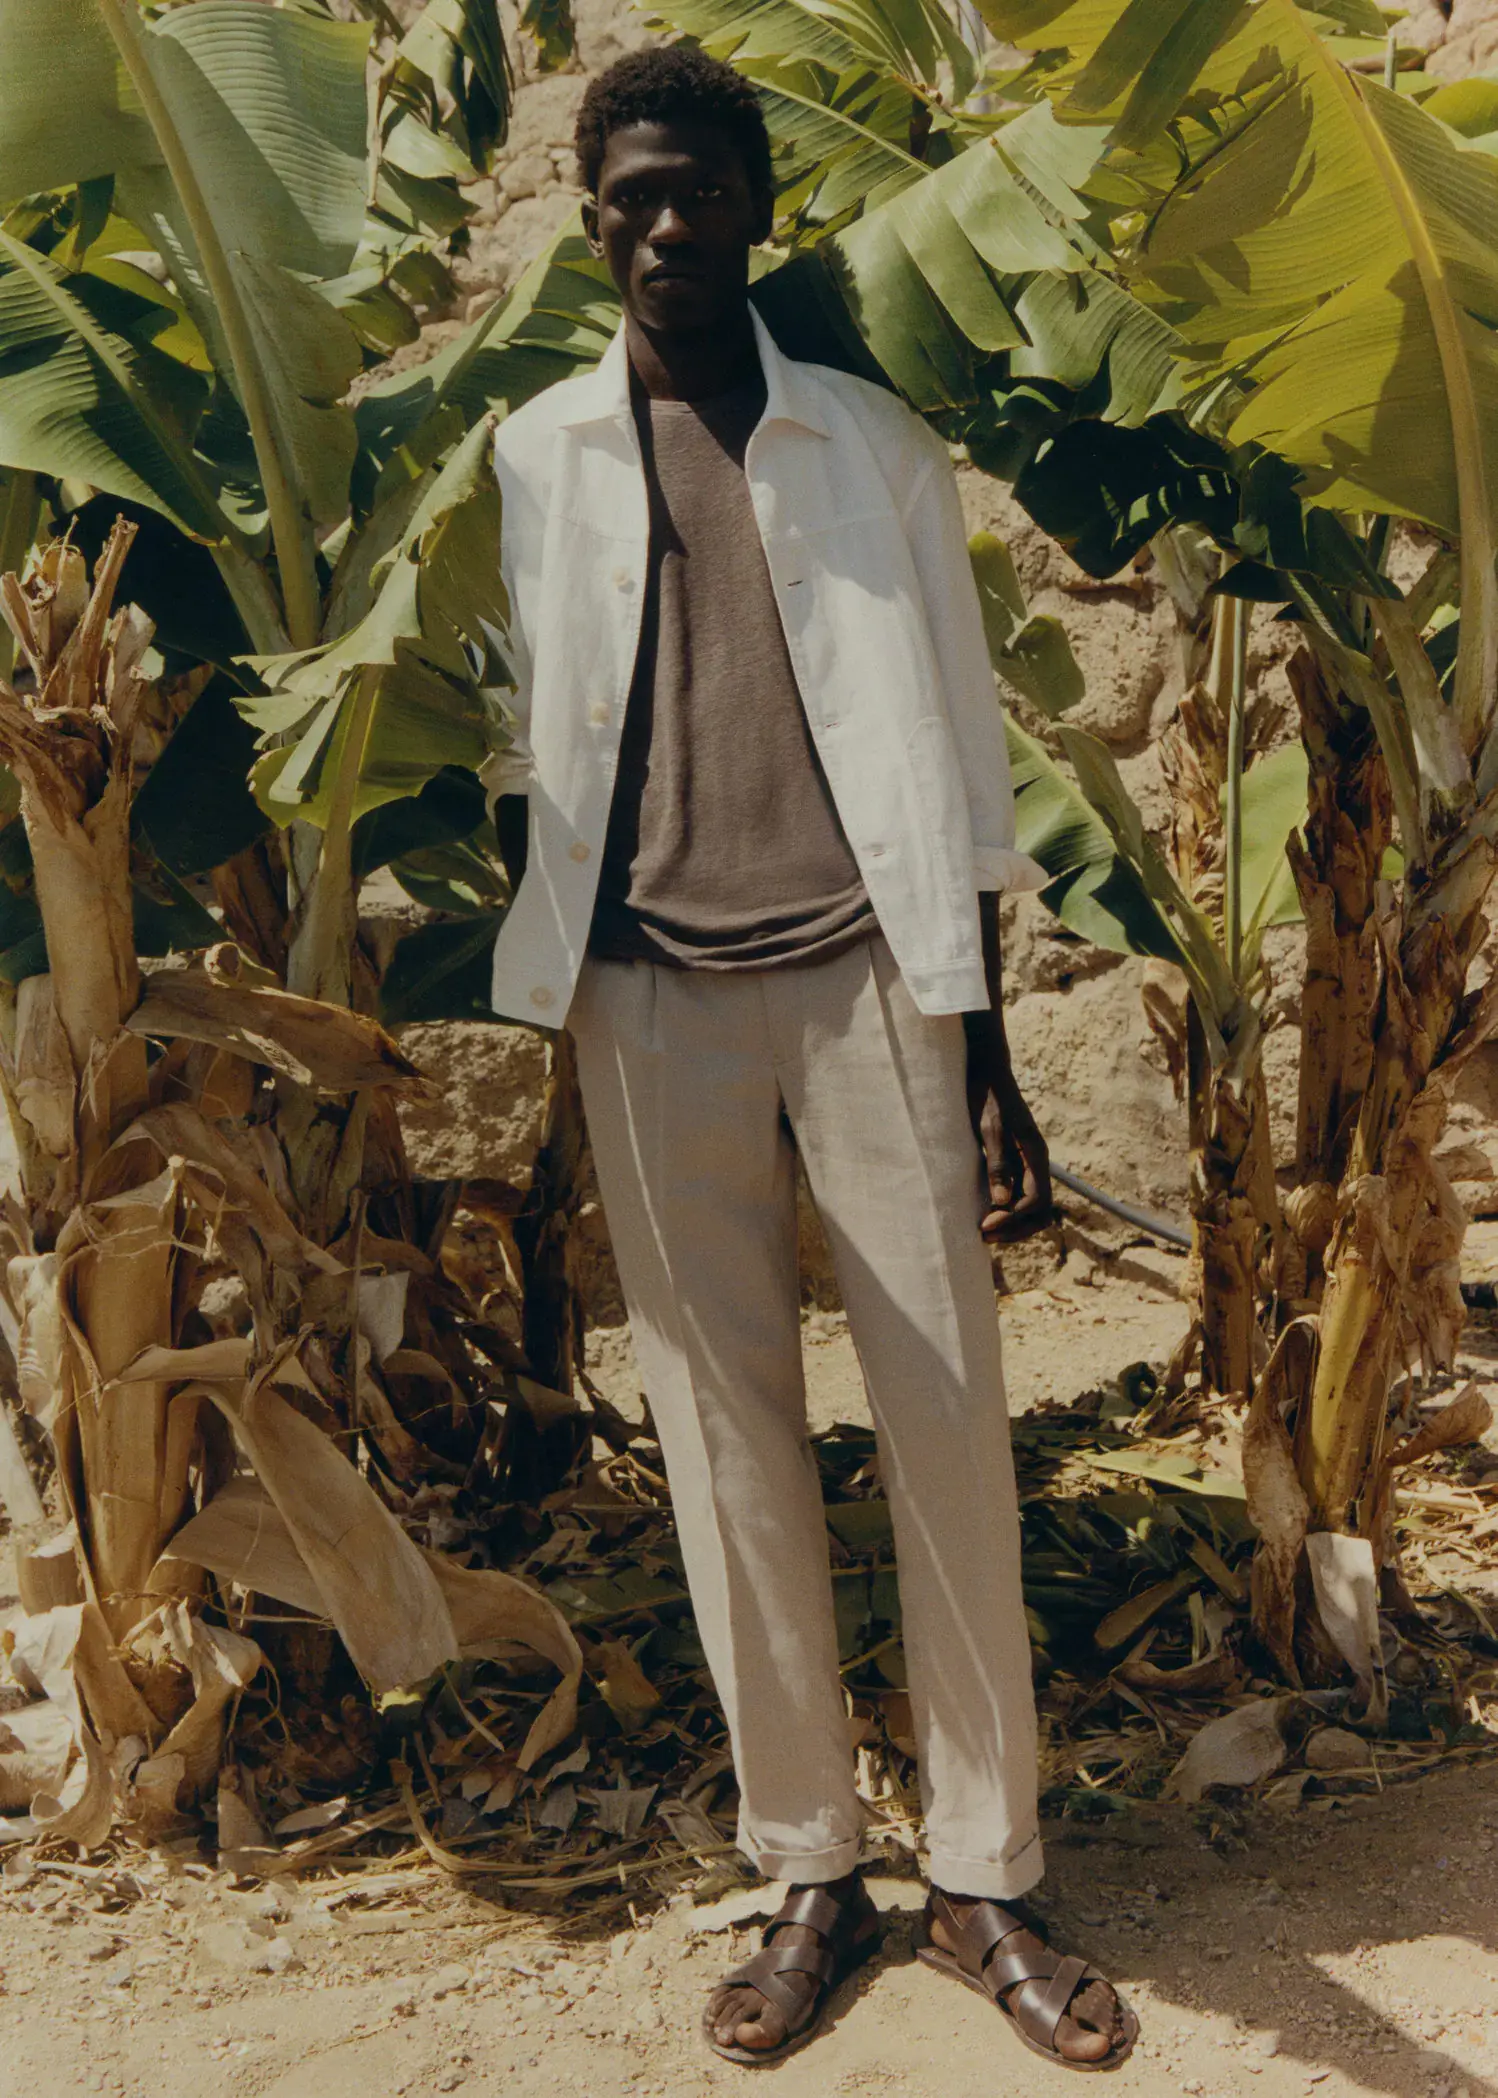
[0,1342,1498,1928]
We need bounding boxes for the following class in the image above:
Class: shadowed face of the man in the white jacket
[583,124,770,336]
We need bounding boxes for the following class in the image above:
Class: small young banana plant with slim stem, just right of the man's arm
[969,535,1307,1397]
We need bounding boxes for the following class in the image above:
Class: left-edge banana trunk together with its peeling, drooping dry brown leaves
[0,525,581,1848]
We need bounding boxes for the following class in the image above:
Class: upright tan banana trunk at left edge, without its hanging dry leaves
[0,525,197,1735]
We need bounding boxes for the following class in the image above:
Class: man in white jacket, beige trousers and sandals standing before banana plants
[493,46,1137,2069]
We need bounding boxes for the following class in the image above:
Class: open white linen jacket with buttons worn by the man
[485,315,1047,1026]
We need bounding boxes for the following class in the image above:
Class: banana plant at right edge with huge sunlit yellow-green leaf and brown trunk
[969,0,1498,1678]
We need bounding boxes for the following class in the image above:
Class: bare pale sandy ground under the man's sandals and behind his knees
[0,1244,1498,2098]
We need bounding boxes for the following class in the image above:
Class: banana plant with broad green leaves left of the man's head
[0,0,598,1001]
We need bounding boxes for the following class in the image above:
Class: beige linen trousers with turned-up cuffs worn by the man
[569,938,1041,1899]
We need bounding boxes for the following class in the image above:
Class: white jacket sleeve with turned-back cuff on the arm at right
[904,432,1051,890]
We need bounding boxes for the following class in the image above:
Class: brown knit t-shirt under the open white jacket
[590,367,877,969]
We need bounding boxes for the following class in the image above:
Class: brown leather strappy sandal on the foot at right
[917,1886,1139,2069]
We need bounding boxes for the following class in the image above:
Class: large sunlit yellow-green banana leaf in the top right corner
[986,0,1498,730]
